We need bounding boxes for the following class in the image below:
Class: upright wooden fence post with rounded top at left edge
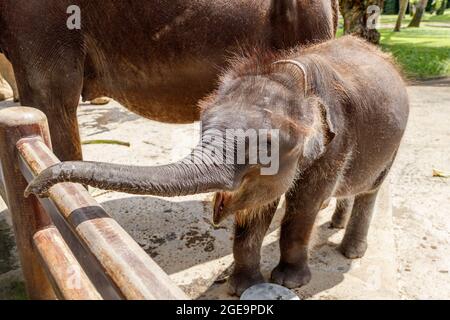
[0,107,56,300]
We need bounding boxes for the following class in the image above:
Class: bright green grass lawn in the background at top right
[339,10,450,79]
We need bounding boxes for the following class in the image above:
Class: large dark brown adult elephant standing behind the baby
[0,0,338,160]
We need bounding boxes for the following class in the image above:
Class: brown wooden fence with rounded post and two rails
[0,107,187,300]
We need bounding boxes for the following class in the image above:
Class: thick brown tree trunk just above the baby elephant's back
[340,0,384,44]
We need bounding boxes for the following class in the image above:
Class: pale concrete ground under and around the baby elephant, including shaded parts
[0,81,450,299]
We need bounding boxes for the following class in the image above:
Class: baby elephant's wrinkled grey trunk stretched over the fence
[25,147,235,197]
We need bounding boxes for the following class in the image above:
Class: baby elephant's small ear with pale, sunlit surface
[303,97,336,160]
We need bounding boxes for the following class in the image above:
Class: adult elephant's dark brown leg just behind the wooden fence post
[15,52,84,161]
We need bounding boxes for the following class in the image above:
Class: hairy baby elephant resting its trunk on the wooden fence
[27,36,409,295]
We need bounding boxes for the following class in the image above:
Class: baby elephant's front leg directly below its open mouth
[228,200,279,296]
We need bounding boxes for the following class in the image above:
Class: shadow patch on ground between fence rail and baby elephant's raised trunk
[101,196,233,274]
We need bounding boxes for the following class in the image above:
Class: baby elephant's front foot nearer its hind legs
[271,263,312,289]
